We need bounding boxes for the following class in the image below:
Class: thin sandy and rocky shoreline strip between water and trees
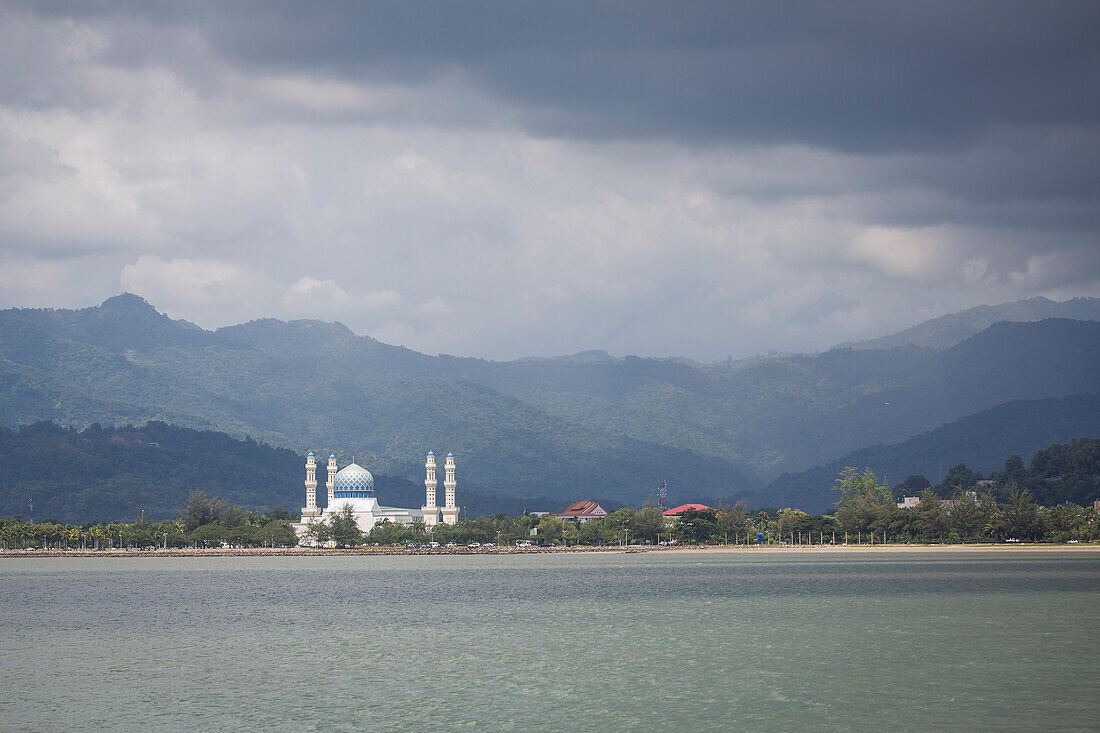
[0,543,1100,560]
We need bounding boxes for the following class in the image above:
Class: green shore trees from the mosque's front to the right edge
[297,468,1100,547]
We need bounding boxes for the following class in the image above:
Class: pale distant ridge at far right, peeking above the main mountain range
[838,297,1100,351]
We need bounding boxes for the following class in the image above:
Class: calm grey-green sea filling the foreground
[0,551,1100,732]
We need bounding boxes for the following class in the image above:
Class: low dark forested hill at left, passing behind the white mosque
[0,422,580,524]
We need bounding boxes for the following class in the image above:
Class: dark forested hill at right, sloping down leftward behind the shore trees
[756,394,1100,512]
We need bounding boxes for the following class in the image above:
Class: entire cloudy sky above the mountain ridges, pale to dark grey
[0,0,1100,360]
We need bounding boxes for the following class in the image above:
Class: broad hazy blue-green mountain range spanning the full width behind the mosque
[0,295,1100,502]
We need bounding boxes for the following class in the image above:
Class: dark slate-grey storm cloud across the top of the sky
[21,1,1100,152]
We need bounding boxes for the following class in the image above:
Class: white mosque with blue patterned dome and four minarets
[292,450,459,540]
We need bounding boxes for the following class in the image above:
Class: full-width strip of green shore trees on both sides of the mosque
[0,464,1100,549]
